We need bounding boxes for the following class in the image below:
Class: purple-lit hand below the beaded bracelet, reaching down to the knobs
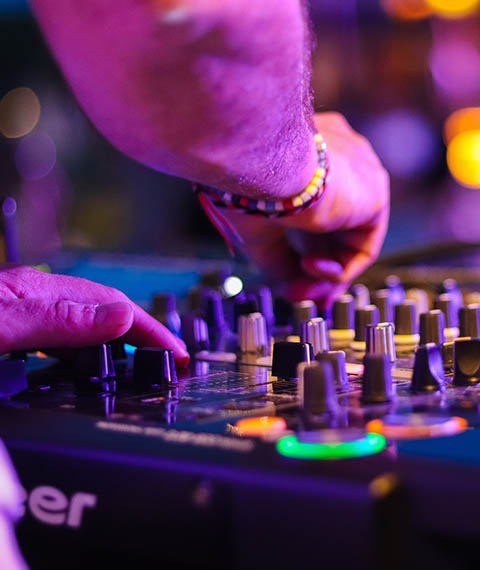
[221,113,389,305]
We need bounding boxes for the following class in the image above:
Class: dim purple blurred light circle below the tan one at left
[15,132,57,180]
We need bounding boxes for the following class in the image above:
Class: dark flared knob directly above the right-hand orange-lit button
[410,340,445,392]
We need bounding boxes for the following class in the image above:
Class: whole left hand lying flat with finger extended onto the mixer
[0,264,189,366]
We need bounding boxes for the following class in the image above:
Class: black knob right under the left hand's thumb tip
[74,344,115,390]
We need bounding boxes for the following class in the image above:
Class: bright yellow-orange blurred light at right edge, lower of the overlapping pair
[447,129,480,188]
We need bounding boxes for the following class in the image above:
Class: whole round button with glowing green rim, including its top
[276,430,386,460]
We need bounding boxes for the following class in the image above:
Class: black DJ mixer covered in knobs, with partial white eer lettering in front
[0,258,480,570]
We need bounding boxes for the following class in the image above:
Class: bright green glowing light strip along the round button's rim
[277,433,387,459]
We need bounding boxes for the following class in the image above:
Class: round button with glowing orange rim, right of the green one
[366,414,468,439]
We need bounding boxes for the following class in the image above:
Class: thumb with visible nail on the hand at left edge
[0,299,133,353]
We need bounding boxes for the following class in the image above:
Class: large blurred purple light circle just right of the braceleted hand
[364,109,438,178]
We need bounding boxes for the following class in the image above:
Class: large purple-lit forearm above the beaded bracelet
[32,0,315,197]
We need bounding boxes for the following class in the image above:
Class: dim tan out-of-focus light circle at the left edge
[0,87,40,139]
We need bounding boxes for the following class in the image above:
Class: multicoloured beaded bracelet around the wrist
[193,133,330,218]
